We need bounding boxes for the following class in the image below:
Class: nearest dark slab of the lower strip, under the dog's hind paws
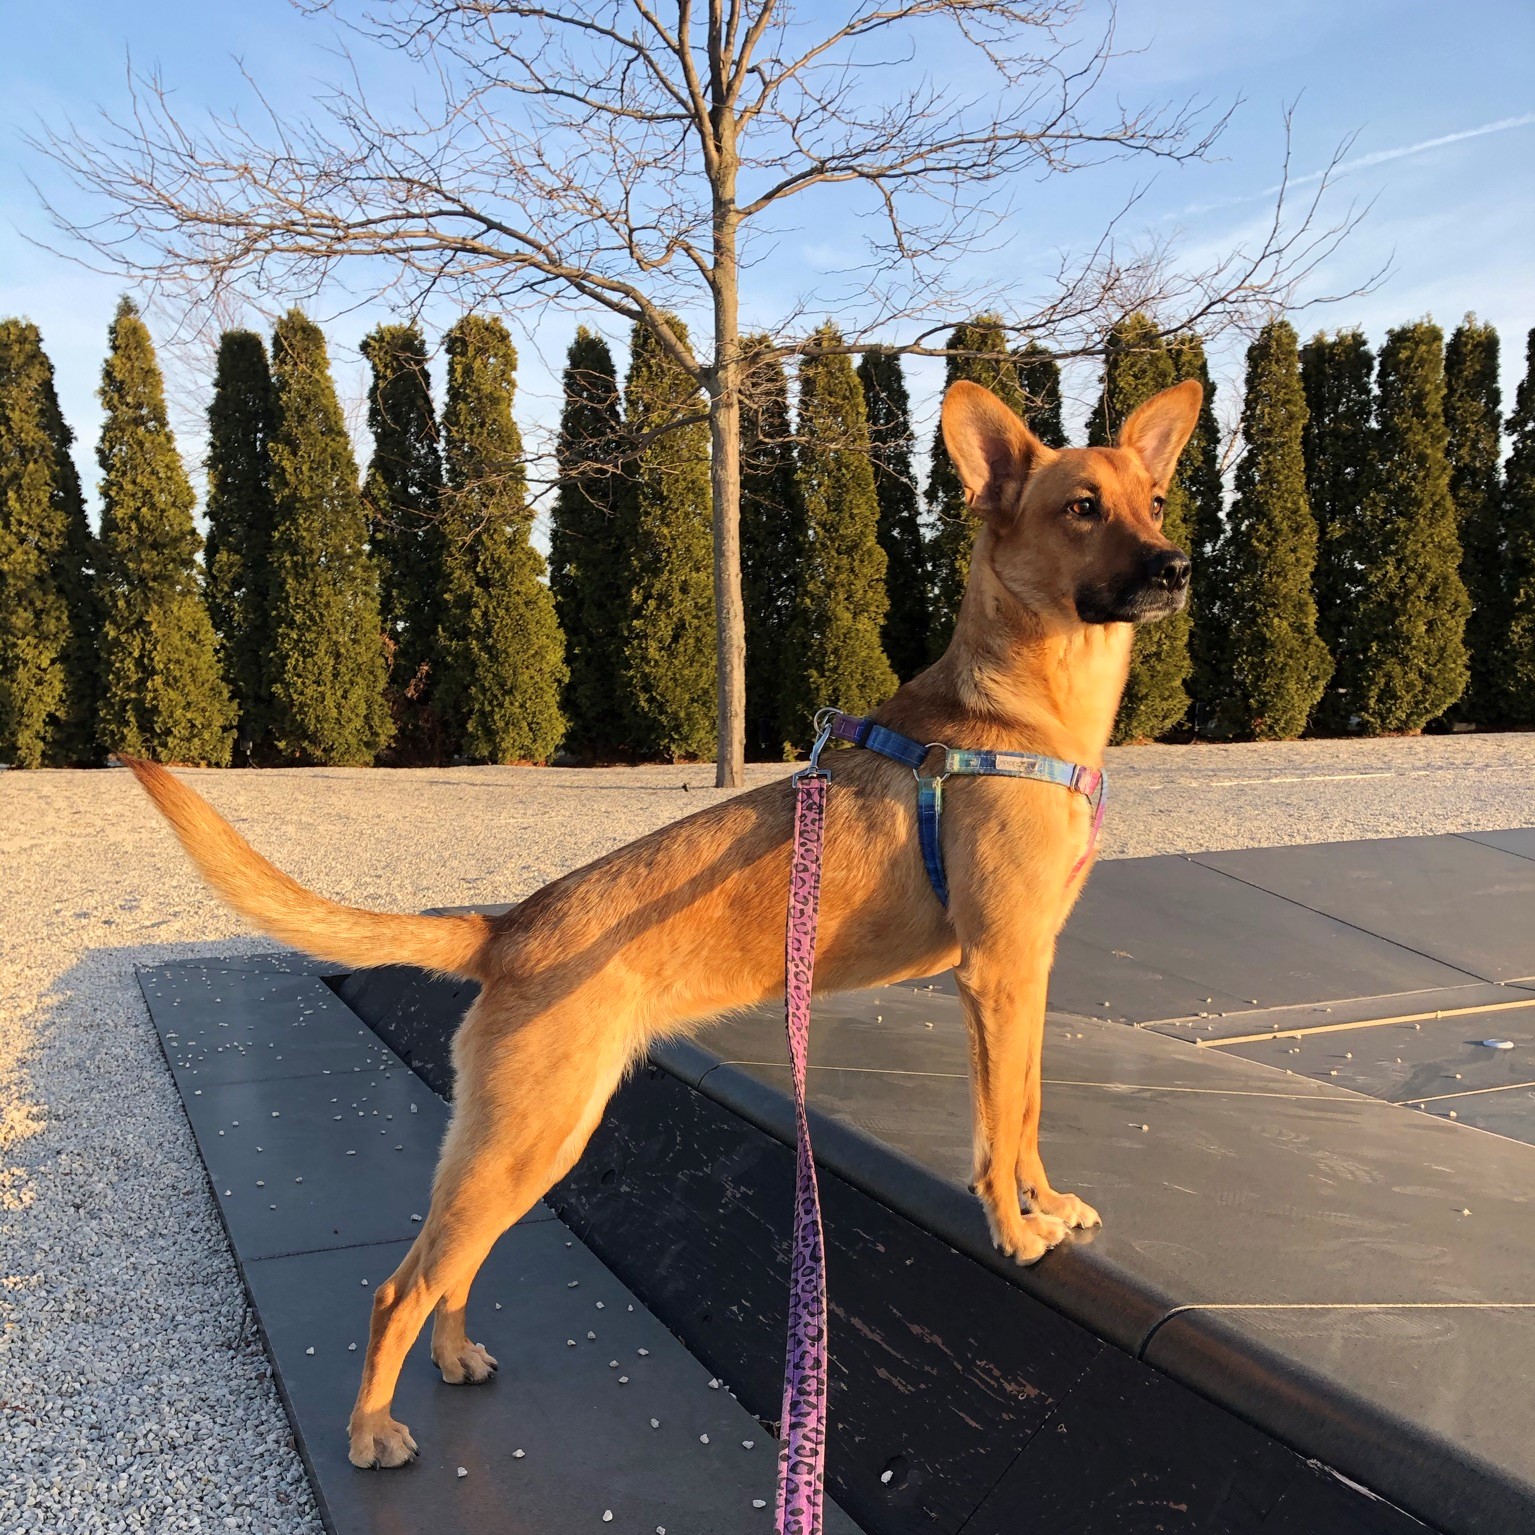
[246,1222,857,1535]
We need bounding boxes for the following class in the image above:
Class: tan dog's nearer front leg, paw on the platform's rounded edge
[955,942,1067,1263]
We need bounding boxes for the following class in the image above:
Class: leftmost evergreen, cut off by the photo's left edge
[0,319,97,768]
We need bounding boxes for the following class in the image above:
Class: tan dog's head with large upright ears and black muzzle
[942,379,1203,623]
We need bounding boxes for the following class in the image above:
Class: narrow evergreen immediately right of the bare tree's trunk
[741,336,804,758]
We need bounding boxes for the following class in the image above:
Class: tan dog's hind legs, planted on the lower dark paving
[348,999,626,1466]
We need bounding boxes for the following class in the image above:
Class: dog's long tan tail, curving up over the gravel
[118,754,491,979]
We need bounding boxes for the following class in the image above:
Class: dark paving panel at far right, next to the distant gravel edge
[1191,837,1535,982]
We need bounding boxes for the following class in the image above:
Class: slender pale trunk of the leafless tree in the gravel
[709,198,746,789]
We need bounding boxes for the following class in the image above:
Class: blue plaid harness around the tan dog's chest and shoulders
[810,709,1108,907]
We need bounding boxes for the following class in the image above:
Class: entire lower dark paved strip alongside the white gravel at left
[140,956,857,1535]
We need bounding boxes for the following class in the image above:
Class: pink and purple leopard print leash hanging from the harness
[778,779,829,1535]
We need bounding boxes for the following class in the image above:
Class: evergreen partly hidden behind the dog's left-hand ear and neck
[927,315,1028,660]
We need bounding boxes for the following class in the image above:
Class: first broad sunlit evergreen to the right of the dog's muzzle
[1220,321,1332,741]
